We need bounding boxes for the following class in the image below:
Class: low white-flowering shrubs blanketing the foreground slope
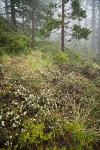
[0,56,99,150]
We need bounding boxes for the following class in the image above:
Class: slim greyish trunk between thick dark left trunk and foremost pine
[32,7,35,49]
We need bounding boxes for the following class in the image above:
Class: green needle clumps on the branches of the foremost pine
[40,0,91,39]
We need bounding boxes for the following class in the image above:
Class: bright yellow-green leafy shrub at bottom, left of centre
[15,121,52,150]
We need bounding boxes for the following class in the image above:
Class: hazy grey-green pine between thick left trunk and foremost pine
[13,0,47,48]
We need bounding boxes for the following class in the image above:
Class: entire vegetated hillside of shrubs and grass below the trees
[0,18,100,150]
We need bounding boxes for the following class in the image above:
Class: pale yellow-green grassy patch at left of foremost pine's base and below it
[28,47,68,70]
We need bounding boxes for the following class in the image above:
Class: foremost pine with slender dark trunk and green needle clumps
[42,0,90,51]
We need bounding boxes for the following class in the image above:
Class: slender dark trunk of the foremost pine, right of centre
[61,0,64,52]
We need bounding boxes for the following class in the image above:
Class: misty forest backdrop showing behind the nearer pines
[0,0,100,54]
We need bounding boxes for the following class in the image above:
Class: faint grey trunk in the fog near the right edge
[92,0,96,50]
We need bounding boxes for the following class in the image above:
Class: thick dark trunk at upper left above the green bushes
[10,0,16,28]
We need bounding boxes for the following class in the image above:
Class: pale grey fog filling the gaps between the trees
[0,0,100,53]
